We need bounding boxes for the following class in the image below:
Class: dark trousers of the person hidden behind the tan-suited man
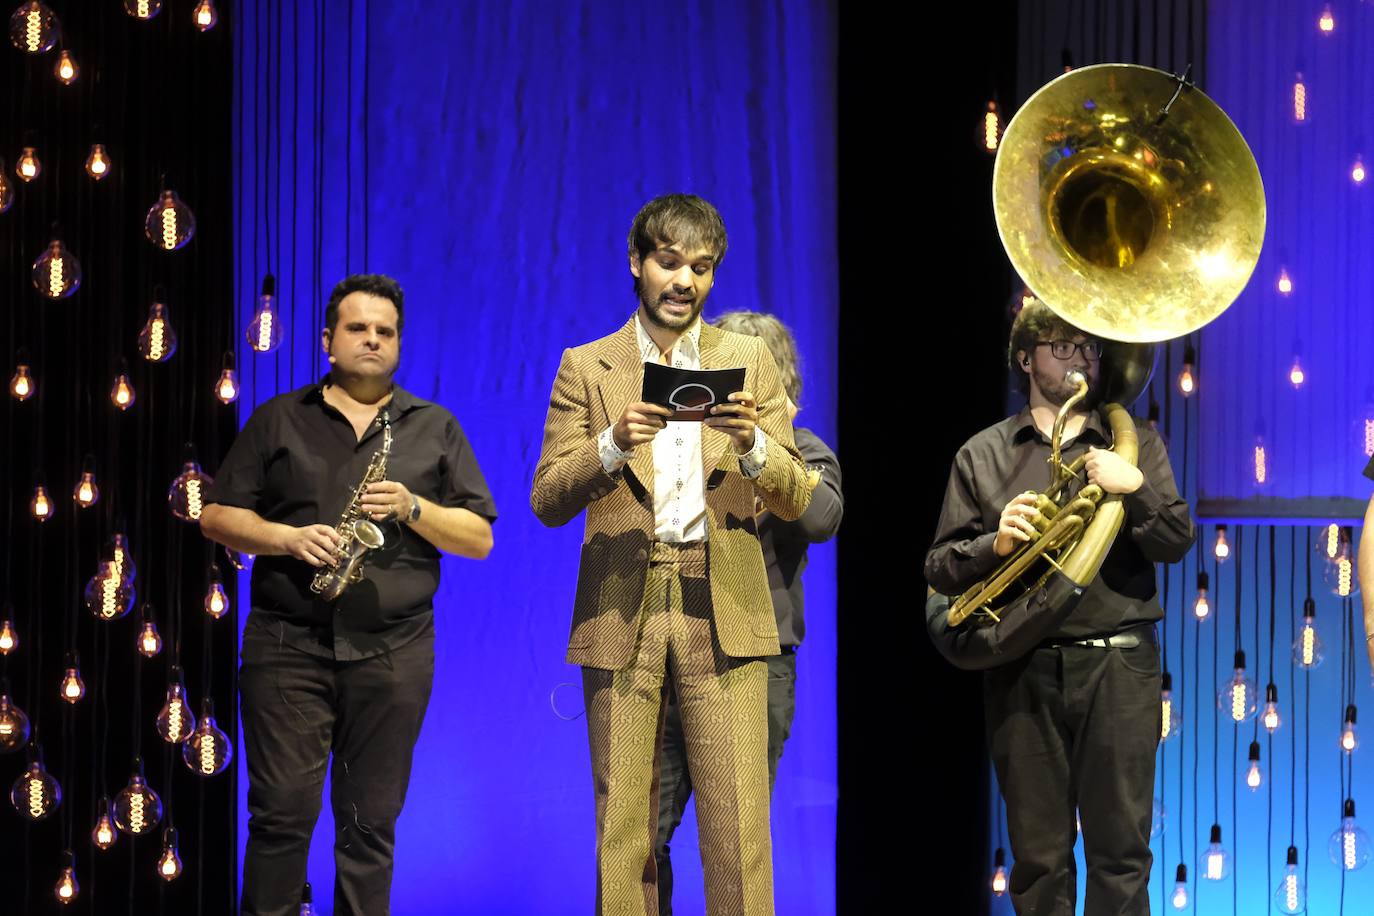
[654,652,797,916]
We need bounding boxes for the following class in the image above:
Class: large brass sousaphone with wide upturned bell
[927,63,1264,667]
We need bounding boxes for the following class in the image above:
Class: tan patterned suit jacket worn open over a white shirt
[529,317,811,670]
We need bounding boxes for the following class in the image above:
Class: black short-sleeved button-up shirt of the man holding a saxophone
[207,378,496,661]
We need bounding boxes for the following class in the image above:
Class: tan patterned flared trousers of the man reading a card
[583,544,774,916]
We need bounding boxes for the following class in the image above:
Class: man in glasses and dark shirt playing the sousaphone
[925,301,1194,916]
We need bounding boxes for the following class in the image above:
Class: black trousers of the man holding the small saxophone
[239,621,434,916]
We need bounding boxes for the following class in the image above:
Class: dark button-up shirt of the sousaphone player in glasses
[926,408,1195,639]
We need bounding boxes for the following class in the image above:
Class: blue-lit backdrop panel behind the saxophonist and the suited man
[229,0,844,915]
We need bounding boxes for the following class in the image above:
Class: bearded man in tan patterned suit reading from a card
[530,194,811,916]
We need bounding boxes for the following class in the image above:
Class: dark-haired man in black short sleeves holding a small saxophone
[201,275,496,916]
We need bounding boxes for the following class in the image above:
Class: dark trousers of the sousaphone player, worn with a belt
[984,641,1160,916]
